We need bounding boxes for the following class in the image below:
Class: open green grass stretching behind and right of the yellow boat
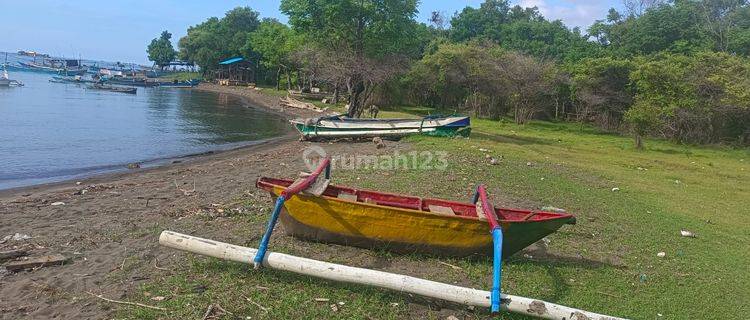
[381,120,750,319]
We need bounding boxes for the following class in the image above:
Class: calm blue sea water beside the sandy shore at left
[0,72,289,189]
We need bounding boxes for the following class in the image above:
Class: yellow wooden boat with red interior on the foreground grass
[256,174,575,258]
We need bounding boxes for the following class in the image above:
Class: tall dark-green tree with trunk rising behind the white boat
[281,0,421,116]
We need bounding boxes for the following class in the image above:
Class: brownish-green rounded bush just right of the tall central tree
[408,41,560,123]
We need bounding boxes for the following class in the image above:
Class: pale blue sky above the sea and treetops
[0,0,622,64]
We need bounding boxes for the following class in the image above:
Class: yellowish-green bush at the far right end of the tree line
[626,52,750,145]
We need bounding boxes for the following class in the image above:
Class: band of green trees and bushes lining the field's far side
[163,0,750,146]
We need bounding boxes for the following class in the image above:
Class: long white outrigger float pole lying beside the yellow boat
[159,230,621,320]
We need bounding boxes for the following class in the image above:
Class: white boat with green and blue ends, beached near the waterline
[290,116,471,140]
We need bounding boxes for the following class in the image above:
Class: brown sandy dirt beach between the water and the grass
[0,85,362,319]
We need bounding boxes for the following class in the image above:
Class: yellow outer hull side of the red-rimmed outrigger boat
[264,180,574,258]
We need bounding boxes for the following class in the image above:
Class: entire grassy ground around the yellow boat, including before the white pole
[121,111,750,319]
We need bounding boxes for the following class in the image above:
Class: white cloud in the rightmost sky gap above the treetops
[517,0,610,30]
